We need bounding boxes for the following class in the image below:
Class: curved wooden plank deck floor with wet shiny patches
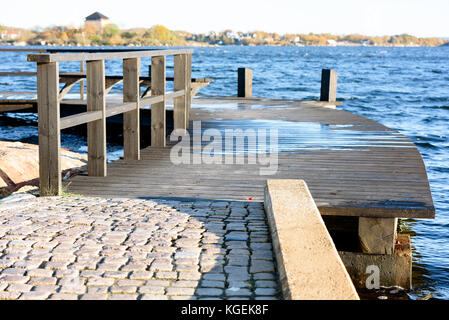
[66,97,435,218]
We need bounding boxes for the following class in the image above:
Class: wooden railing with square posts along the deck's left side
[28,49,193,195]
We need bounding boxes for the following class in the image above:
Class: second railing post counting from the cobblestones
[86,60,106,177]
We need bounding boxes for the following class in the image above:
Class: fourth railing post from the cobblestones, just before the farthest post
[151,56,166,147]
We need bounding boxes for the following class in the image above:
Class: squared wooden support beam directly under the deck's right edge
[359,217,398,254]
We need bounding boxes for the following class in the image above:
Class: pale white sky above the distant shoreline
[0,0,449,38]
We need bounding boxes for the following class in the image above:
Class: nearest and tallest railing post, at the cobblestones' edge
[37,62,62,196]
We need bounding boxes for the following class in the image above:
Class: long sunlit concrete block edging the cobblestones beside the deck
[265,179,359,300]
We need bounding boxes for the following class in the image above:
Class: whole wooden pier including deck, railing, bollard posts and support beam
[1,49,435,292]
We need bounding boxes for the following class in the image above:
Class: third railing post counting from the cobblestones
[123,58,140,160]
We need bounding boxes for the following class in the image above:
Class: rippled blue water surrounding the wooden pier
[0,47,449,299]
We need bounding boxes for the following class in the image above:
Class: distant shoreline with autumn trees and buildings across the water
[0,23,449,47]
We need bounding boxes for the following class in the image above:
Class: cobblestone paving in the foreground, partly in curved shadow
[0,197,280,299]
